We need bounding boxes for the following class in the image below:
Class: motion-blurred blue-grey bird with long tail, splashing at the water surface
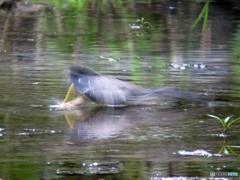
[63,65,208,108]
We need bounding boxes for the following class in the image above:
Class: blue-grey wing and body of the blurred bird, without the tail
[69,66,142,106]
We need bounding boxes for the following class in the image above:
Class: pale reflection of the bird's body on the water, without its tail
[65,107,141,142]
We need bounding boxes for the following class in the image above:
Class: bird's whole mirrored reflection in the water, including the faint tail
[65,106,208,144]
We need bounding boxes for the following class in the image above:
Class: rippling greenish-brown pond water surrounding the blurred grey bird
[0,0,240,180]
